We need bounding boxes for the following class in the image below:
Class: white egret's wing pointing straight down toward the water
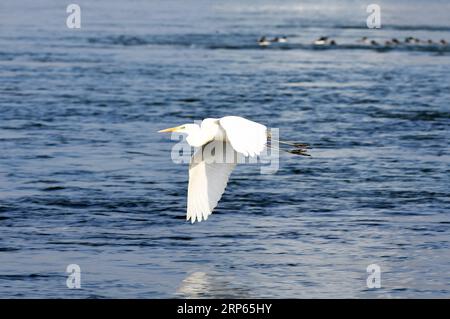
[186,141,236,223]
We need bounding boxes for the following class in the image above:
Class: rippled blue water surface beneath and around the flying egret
[0,0,450,298]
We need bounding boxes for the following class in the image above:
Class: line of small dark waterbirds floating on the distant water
[258,36,448,47]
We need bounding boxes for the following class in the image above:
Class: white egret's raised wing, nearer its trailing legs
[219,116,267,157]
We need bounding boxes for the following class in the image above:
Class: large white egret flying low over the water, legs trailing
[158,116,309,223]
